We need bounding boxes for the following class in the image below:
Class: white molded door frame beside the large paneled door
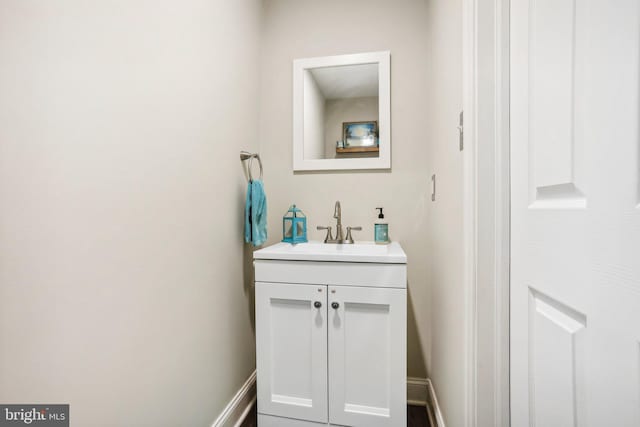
[462,0,510,427]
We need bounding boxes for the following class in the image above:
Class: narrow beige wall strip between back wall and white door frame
[425,0,467,427]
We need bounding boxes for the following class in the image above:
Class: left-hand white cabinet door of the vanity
[256,282,328,423]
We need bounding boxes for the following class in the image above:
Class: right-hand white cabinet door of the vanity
[327,286,407,427]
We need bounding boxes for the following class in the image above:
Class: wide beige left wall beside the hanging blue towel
[0,0,262,427]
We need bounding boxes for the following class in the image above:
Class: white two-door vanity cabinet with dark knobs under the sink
[254,243,407,427]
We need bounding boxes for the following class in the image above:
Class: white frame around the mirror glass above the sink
[293,51,391,171]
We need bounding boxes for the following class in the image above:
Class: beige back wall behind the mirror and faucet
[260,0,430,377]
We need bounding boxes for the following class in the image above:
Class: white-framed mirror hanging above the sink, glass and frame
[293,52,391,171]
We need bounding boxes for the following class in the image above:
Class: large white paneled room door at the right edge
[511,0,640,427]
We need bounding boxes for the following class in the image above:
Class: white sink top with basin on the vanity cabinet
[253,241,407,264]
